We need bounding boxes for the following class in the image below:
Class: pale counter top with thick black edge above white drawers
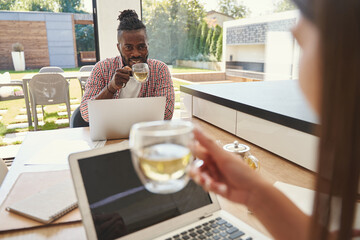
[180,80,318,134]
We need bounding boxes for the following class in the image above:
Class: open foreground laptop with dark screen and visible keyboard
[69,143,269,240]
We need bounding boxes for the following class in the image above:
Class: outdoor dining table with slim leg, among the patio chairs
[22,72,91,127]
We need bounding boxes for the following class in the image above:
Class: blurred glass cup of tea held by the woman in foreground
[129,120,194,194]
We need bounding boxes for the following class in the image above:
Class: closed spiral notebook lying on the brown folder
[6,181,77,223]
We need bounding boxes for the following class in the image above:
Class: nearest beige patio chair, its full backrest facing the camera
[29,73,71,131]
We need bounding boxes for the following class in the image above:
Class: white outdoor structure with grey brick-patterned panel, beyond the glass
[223,10,300,80]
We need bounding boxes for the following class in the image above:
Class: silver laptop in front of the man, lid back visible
[88,97,166,141]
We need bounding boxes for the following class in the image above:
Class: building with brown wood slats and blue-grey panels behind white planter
[0,11,92,70]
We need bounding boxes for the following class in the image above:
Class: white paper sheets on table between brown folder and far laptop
[25,140,91,165]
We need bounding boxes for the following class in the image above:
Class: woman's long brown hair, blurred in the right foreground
[294,0,360,239]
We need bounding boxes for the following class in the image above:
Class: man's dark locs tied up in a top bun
[117,9,146,31]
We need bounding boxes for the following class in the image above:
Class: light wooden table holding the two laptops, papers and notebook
[0,118,315,239]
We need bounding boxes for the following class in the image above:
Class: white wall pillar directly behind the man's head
[96,0,141,60]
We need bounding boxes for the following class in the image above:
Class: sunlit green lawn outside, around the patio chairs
[0,67,205,146]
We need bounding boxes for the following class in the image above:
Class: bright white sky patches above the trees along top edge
[83,0,278,16]
